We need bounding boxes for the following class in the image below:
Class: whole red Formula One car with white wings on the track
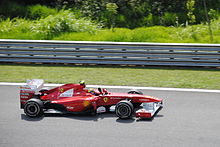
[20,79,163,119]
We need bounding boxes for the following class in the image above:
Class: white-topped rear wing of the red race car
[20,79,44,108]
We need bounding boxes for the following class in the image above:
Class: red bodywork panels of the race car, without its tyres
[20,84,162,118]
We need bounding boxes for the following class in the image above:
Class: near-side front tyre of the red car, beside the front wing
[115,100,134,119]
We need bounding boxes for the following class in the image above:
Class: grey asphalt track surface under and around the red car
[0,86,220,147]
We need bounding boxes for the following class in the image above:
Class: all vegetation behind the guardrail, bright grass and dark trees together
[0,0,220,43]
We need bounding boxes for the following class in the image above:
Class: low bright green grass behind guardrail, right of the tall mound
[53,23,220,43]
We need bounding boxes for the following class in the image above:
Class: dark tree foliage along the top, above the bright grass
[0,0,220,28]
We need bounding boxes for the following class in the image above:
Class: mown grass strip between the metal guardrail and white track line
[0,64,220,89]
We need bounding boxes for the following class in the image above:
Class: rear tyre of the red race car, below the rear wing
[24,98,43,117]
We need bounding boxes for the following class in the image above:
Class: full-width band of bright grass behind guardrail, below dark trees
[0,13,220,43]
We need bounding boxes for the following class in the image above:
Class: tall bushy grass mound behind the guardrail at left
[0,10,99,40]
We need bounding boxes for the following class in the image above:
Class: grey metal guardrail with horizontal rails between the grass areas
[0,39,220,67]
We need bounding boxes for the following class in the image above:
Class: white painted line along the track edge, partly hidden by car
[0,82,220,93]
